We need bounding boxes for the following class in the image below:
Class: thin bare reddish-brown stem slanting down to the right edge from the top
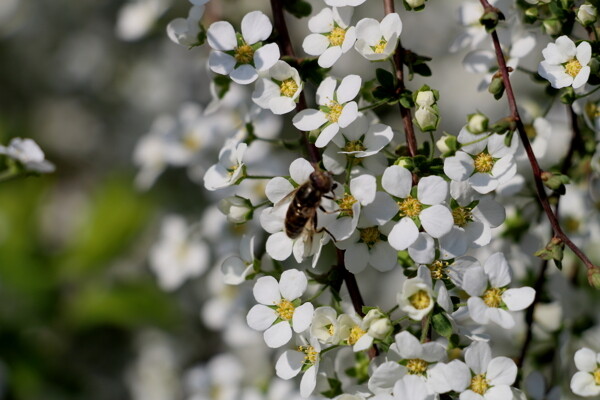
[480,0,598,284]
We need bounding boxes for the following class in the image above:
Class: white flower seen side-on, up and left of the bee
[204,140,248,190]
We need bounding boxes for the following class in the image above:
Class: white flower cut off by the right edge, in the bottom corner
[571,347,600,397]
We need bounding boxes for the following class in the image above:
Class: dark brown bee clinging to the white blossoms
[285,169,334,239]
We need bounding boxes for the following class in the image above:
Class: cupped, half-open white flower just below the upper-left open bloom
[252,61,303,114]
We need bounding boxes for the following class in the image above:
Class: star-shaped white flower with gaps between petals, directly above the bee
[292,75,362,147]
